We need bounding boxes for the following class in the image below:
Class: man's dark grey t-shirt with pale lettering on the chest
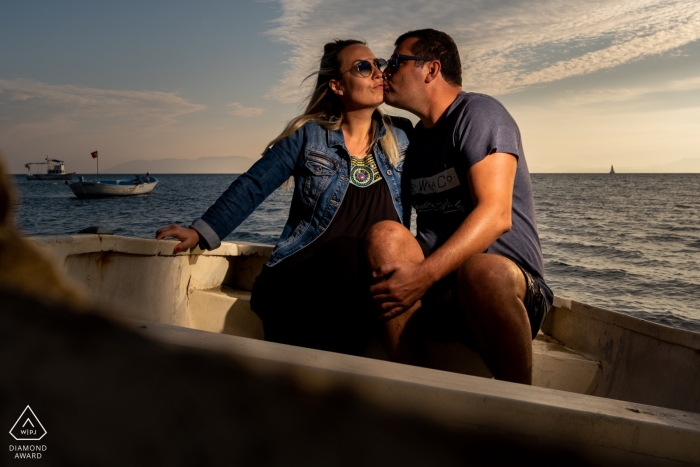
[403,92,552,303]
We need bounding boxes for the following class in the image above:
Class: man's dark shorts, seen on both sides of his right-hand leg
[417,252,551,349]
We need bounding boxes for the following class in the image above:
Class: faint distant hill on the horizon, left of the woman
[104,156,255,175]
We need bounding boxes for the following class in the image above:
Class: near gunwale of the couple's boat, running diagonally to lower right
[124,319,700,463]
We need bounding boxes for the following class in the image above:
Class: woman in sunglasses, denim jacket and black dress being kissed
[156,40,412,354]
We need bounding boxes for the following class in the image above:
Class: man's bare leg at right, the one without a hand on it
[457,253,532,384]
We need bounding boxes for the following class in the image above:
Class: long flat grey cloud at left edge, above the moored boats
[0,79,206,132]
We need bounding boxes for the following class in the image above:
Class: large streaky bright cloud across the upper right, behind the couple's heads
[266,0,700,103]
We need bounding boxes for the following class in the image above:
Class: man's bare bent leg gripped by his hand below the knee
[367,221,424,363]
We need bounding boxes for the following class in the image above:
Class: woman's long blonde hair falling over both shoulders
[266,39,399,166]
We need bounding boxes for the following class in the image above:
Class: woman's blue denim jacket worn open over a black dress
[191,113,413,266]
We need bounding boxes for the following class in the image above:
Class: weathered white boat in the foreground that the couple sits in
[30,235,700,465]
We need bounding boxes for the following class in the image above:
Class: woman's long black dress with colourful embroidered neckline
[251,155,399,355]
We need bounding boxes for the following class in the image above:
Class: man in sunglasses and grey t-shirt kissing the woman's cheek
[368,29,553,384]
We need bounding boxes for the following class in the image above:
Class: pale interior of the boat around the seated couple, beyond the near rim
[31,235,700,412]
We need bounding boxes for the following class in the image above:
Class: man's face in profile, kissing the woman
[384,37,427,112]
